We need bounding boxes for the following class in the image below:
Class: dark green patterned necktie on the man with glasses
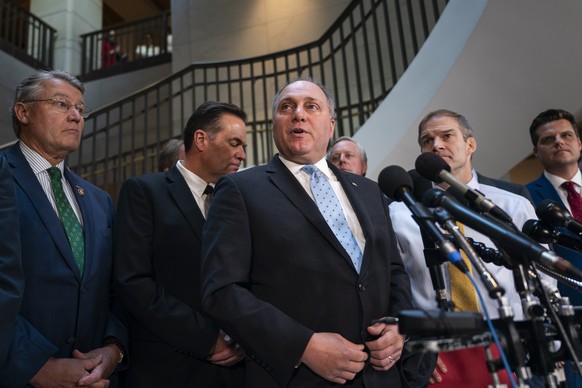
[47,167,85,275]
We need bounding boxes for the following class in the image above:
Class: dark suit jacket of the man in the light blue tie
[202,156,422,387]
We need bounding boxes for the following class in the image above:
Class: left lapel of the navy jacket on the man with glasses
[6,143,81,279]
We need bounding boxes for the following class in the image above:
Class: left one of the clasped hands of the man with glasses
[30,356,109,388]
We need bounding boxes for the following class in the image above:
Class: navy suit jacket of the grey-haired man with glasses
[0,143,126,388]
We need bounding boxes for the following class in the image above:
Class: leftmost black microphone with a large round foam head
[378,166,469,273]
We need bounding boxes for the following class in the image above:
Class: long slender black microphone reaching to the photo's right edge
[422,189,582,280]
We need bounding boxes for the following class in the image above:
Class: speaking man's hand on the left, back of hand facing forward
[301,333,368,384]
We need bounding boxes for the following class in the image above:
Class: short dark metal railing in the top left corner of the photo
[0,0,57,69]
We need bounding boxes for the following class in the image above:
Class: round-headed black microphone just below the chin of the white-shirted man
[414,152,512,223]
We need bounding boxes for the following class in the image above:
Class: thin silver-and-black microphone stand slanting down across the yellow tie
[433,207,531,386]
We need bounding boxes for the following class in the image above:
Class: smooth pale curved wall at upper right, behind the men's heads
[362,0,582,179]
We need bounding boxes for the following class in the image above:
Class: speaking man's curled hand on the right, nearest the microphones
[366,323,404,371]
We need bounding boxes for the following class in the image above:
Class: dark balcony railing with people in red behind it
[79,12,172,81]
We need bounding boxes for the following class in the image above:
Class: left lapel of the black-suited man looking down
[166,166,205,240]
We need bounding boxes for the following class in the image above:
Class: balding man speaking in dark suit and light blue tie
[202,79,422,388]
